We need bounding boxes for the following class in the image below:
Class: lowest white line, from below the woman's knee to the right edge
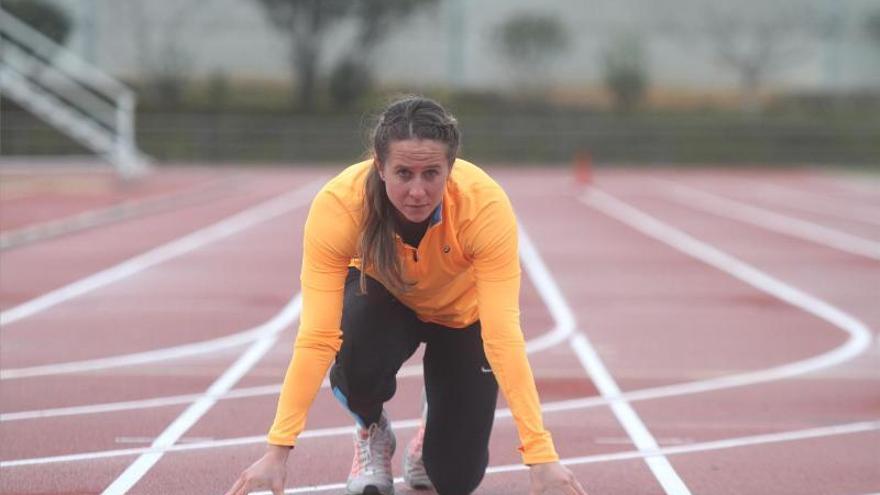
[253,421,880,495]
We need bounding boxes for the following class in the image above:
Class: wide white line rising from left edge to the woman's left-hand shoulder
[0,178,325,329]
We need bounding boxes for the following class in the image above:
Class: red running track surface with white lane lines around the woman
[0,164,880,495]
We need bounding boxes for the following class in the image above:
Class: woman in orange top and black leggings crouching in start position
[228,97,585,495]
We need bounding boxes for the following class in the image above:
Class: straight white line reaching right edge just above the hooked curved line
[654,179,880,260]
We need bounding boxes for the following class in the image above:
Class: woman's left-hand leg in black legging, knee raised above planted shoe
[330,269,425,428]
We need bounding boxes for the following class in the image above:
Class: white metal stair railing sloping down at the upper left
[0,8,149,177]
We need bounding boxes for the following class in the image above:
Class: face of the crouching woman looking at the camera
[379,139,452,222]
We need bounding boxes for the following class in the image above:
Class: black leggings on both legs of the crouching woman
[330,269,498,495]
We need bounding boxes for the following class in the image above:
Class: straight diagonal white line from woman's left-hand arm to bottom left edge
[102,295,302,495]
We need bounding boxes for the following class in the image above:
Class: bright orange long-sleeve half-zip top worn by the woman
[268,160,559,464]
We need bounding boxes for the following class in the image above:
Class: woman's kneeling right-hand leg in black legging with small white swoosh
[422,323,498,495]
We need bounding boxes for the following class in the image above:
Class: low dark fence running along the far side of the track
[0,108,880,168]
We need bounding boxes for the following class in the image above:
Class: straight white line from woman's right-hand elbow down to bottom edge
[520,226,691,495]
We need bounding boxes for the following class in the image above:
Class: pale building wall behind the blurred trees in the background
[54,0,880,89]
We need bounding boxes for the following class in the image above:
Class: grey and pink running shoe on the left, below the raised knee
[345,411,397,495]
